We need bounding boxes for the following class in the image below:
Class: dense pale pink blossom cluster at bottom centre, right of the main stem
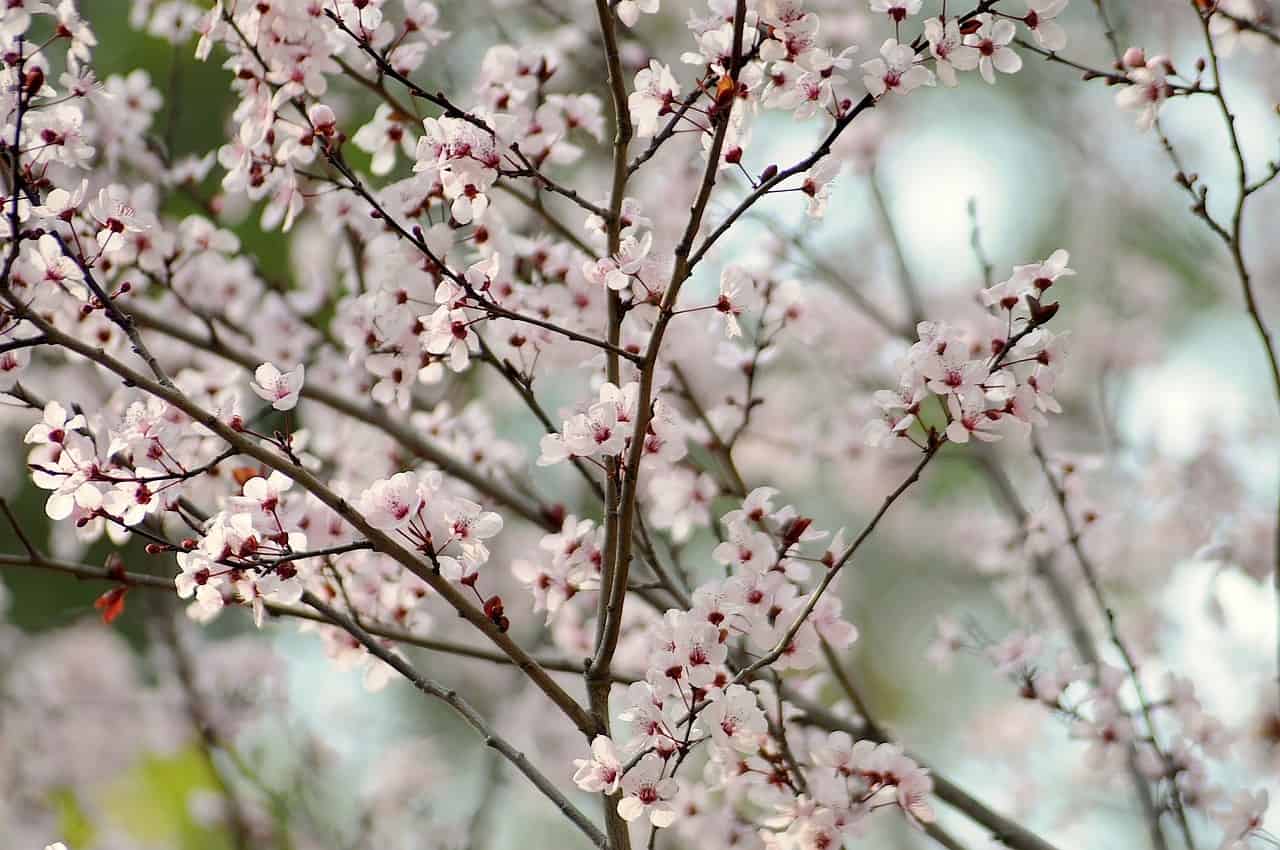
[570,488,933,847]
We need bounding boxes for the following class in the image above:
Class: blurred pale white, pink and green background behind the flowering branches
[0,0,1280,850]
